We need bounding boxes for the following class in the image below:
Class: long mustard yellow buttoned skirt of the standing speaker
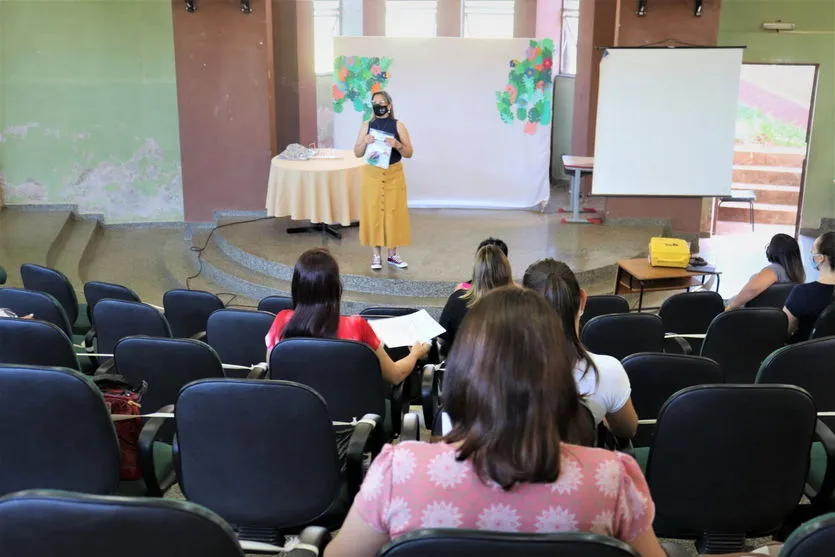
[360,162,412,248]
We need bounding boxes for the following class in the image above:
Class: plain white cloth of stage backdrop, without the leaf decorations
[334,37,553,208]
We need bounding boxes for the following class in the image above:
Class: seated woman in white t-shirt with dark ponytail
[522,258,638,438]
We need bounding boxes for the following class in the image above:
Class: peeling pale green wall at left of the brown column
[0,0,183,222]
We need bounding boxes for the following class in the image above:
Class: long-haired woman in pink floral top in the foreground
[325,287,665,557]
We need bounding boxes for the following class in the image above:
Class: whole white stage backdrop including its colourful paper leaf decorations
[331,37,554,208]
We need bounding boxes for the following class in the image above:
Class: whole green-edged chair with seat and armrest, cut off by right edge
[756,337,835,507]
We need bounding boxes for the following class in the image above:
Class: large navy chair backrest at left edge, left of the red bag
[0,365,119,494]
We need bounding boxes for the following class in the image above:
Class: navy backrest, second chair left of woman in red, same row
[93,298,171,360]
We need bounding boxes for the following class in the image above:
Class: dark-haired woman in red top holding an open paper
[265,248,429,385]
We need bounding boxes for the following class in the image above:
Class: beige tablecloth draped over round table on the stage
[267,149,366,226]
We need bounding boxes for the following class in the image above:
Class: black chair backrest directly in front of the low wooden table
[658,291,725,354]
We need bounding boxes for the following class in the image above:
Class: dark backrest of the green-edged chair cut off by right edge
[756,337,835,429]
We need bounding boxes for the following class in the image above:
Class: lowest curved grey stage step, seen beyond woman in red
[191,230,451,319]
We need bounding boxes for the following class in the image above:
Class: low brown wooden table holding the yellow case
[615,257,720,311]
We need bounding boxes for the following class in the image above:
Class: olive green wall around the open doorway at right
[719,0,835,228]
